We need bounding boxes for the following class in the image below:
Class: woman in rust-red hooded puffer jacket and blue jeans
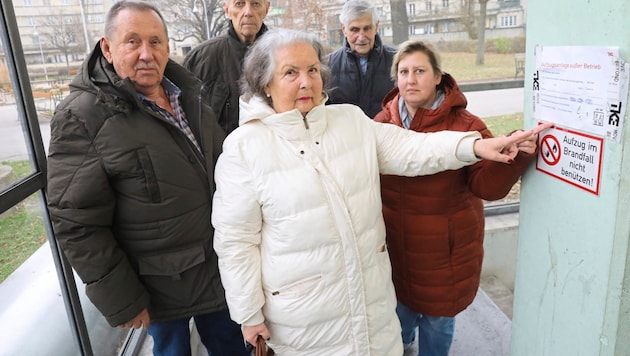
[374,41,537,356]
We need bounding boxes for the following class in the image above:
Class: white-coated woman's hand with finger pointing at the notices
[473,122,553,163]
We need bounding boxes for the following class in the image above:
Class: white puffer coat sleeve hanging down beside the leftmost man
[212,140,265,325]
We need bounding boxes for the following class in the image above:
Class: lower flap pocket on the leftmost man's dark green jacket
[138,246,206,279]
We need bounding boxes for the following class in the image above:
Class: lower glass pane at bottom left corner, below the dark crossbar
[0,195,79,355]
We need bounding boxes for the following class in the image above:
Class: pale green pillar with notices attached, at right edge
[511,0,630,356]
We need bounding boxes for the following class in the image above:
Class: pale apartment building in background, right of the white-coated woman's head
[268,0,527,46]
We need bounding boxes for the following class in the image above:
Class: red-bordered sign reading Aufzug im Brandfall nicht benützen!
[536,126,604,195]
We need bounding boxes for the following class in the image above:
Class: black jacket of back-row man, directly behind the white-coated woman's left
[183,22,267,133]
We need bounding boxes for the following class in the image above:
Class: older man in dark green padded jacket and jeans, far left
[47,1,247,355]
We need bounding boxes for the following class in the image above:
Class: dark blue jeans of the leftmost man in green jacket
[148,310,249,356]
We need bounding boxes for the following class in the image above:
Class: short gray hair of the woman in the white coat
[241,28,331,105]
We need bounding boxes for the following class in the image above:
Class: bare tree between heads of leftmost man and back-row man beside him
[156,0,228,43]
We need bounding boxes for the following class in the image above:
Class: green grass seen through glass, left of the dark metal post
[0,161,46,283]
